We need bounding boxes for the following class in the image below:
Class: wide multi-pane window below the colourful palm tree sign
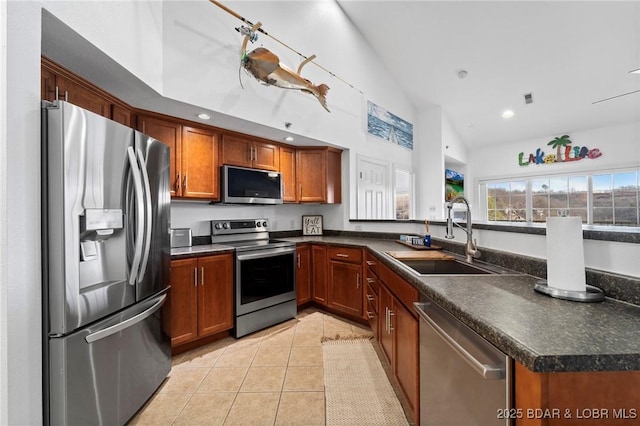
[480,170,640,226]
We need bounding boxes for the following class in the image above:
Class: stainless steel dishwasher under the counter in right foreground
[414,297,513,426]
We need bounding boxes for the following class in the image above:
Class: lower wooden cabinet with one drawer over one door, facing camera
[327,246,362,317]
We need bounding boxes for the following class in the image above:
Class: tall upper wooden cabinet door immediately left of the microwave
[180,126,220,200]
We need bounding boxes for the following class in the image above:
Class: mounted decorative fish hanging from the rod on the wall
[242,47,331,112]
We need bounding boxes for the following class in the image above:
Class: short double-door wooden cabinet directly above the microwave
[220,134,280,171]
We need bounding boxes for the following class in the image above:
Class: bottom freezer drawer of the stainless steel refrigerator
[48,294,171,425]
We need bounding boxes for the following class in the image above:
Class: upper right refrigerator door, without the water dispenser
[135,132,171,300]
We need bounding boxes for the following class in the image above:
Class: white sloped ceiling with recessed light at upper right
[337,0,640,148]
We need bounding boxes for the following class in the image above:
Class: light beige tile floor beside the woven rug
[129,308,371,426]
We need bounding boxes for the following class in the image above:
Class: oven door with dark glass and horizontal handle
[235,246,296,316]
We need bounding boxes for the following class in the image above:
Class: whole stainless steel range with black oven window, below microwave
[211,219,297,337]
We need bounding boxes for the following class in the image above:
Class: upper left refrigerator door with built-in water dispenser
[43,101,135,334]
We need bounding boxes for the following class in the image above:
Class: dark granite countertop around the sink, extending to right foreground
[172,236,640,372]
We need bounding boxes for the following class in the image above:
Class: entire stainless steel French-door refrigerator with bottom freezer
[42,101,171,425]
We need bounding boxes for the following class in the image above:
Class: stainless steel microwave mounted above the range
[220,165,282,204]
